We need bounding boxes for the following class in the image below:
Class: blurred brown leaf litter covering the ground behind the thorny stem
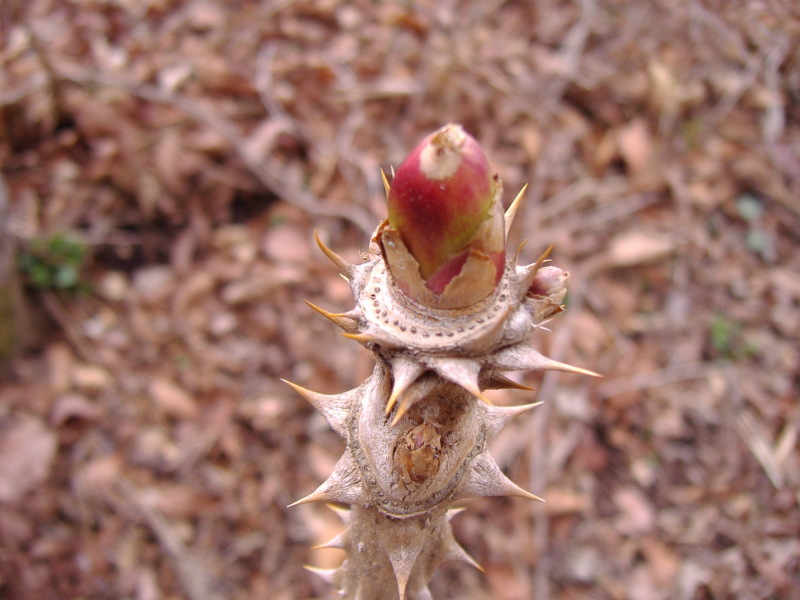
[0,0,800,600]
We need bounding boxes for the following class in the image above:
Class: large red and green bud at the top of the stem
[379,124,505,308]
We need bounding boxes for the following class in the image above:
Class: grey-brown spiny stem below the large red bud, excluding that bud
[287,126,595,600]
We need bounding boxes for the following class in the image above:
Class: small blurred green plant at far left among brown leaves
[17,233,88,291]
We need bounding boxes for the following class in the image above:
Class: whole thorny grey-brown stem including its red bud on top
[290,125,596,600]
